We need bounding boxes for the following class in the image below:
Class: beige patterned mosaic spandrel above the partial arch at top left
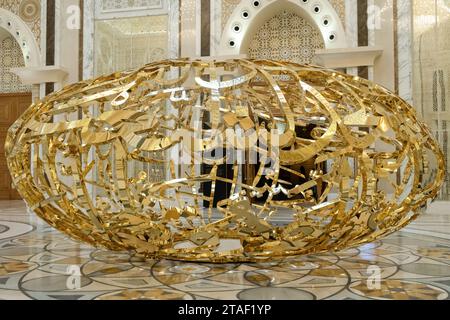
[0,0,41,45]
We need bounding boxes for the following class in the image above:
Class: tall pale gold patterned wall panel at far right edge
[413,0,450,199]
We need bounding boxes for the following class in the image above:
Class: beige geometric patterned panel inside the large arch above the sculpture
[248,11,325,63]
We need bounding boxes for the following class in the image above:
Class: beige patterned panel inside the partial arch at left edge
[0,36,31,93]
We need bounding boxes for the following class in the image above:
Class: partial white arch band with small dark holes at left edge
[0,8,41,67]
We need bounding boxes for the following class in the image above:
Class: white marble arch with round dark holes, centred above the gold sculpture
[218,0,347,55]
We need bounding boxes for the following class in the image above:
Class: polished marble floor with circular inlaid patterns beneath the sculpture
[0,201,450,300]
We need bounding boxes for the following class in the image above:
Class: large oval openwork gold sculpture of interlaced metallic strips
[6,60,444,262]
